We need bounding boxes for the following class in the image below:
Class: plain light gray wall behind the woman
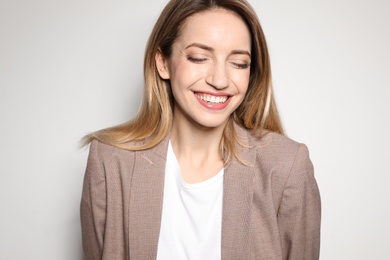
[0,0,390,260]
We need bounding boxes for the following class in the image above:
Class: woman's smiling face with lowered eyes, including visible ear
[156,9,251,128]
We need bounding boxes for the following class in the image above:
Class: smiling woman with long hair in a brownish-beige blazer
[81,0,320,260]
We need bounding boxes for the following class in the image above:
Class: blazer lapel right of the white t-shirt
[221,129,256,260]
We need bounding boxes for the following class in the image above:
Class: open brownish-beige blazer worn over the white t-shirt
[81,125,321,260]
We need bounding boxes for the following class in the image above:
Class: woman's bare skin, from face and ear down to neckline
[156,8,251,183]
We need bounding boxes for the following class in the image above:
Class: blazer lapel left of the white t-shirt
[128,137,169,259]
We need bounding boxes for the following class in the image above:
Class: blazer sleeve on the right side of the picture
[278,144,321,260]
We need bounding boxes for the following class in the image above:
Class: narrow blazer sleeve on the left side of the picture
[80,140,106,260]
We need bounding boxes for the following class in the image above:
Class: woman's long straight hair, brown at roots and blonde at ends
[82,0,283,162]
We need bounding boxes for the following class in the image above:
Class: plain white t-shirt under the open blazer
[157,142,224,260]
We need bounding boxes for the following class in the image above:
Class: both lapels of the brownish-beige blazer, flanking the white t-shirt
[128,127,256,260]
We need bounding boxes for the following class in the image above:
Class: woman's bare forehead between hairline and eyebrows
[176,8,251,51]
